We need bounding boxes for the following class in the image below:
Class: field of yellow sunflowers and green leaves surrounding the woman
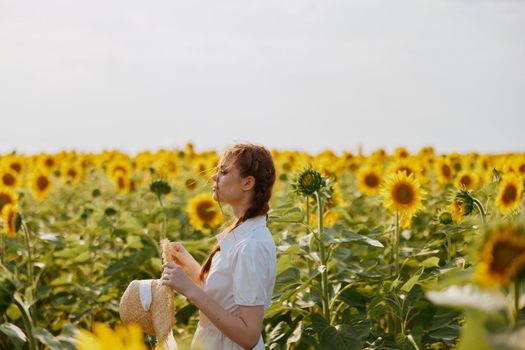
[0,144,525,350]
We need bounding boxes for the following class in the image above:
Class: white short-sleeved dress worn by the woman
[191,216,277,350]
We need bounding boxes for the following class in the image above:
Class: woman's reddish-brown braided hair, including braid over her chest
[199,144,275,281]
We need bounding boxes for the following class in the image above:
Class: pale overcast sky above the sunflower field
[0,0,525,154]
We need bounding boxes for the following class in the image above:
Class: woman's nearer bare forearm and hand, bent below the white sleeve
[162,263,264,349]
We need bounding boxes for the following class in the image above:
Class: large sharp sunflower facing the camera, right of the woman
[380,171,426,228]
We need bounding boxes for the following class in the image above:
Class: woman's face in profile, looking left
[212,161,248,204]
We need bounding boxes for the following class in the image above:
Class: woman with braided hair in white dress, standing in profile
[162,144,276,350]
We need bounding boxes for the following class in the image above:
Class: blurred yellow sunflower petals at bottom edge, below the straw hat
[75,322,147,350]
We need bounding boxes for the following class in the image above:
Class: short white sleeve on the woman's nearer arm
[233,242,270,306]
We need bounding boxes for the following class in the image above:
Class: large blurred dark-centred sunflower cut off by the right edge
[474,224,525,287]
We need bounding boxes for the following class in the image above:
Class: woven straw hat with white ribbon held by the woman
[119,239,176,349]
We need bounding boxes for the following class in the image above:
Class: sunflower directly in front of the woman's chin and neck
[186,192,222,233]
